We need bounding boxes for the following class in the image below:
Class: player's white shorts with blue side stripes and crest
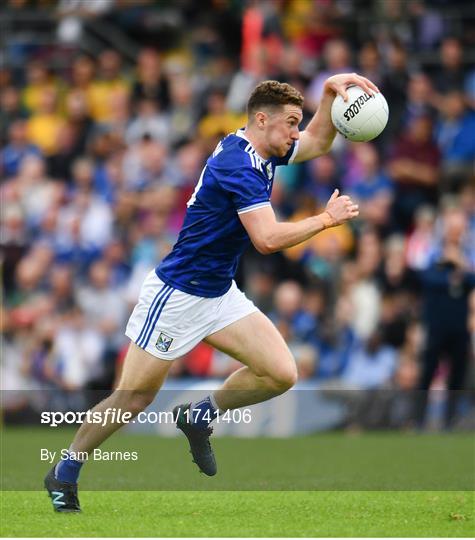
[125,270,258,360]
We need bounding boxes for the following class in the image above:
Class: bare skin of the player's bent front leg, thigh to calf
[205,311,297,410]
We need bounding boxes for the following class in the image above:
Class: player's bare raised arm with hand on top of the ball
[294,73,379,163]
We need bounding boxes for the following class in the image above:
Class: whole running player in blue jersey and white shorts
[45,73,378,512]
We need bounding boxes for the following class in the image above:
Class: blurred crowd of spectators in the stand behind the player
[0,0,475,430]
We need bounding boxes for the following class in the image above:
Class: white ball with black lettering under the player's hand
[331,86,389,142]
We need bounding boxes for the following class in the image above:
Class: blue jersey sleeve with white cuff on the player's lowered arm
[217,167,270,214]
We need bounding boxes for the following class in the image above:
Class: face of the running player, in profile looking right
[266,105,303,157]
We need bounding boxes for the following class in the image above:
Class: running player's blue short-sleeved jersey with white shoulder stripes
[155,130,297,298]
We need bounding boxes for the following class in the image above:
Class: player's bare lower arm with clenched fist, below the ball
[239,189,359,255]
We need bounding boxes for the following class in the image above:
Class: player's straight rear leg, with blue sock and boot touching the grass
[45,342,171,512]
